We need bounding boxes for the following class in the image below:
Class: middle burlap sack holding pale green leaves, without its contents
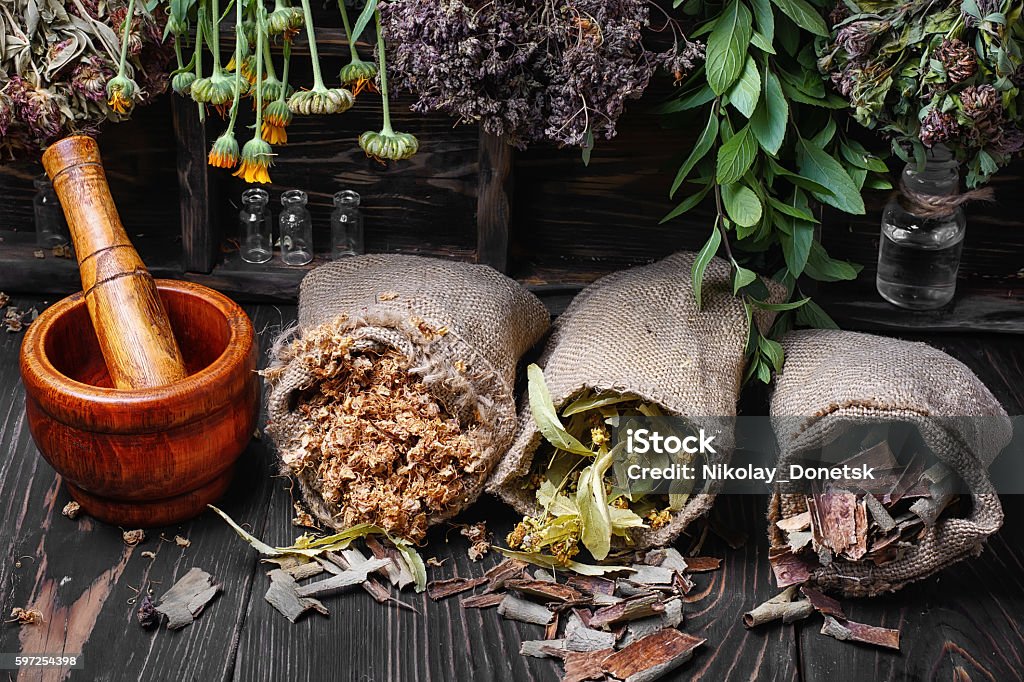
[487,253,781,548]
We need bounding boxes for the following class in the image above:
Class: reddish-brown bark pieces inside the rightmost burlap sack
[768,440,959,588]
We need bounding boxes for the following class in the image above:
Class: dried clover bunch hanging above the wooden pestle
[0,0,171,159]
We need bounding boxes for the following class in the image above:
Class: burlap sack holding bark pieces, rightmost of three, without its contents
[768,330,1012,596]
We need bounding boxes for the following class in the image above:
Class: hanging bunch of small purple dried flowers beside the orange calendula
[380,0,703,147]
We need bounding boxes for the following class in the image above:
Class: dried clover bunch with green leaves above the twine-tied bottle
[818,0,1024,187]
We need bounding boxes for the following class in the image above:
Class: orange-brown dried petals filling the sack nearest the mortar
[268,328,479,542]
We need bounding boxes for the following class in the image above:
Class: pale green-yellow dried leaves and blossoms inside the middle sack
[506,365,690,567]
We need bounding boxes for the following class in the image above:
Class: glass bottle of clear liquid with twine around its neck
[876,145,967,310]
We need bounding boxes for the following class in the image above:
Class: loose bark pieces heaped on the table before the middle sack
[427,549,721,681]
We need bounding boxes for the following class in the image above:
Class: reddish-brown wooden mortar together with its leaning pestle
[20,137,259,527]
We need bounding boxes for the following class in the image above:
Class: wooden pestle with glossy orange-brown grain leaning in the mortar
[43,135,187,388]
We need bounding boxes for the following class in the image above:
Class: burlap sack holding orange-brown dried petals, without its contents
[267,254,550,527]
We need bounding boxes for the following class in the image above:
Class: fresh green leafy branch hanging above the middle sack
[660,0,891,383]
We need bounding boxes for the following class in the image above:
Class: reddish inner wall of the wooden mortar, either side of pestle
[45,289,231,388]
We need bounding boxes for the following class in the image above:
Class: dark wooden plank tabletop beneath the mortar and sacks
[0,300,1024,682]
